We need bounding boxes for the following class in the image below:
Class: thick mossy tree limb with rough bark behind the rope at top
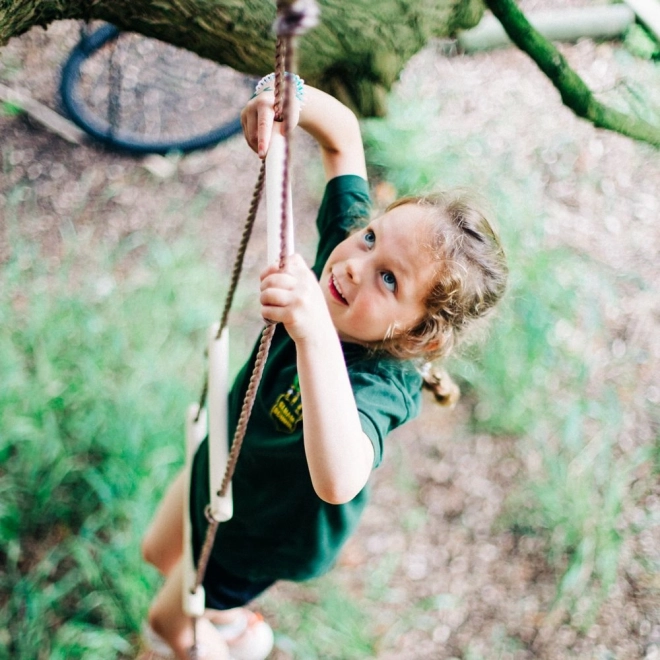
[0,0,483,116]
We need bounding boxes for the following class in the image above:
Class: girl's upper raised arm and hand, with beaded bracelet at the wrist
[241,85,367,186]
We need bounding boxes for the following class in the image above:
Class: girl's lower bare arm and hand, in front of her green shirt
[260,254,374,504]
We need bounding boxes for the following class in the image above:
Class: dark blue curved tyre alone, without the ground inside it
[60,23,242,155]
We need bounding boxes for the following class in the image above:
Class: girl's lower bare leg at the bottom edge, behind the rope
[149,564,229,660]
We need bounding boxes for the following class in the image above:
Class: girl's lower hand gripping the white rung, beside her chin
[260,254,332,343]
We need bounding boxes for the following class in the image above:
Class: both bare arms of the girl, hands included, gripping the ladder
[241,77,374,504]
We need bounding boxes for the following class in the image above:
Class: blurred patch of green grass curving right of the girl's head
[365,84,649,625]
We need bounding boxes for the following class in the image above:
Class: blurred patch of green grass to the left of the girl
[0,229,226,660]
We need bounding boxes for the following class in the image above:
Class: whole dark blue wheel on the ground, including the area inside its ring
[60,24,252,154]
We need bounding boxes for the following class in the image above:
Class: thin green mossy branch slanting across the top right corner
[485,0,660,147]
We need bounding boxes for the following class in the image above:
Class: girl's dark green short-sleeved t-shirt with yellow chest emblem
[191,175,421,580]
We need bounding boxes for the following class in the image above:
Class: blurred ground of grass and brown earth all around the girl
[0,2,660,660]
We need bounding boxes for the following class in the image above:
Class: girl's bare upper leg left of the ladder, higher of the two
[142,471,189,575]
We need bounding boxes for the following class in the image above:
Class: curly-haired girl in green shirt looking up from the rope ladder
[143,84,507,660]
